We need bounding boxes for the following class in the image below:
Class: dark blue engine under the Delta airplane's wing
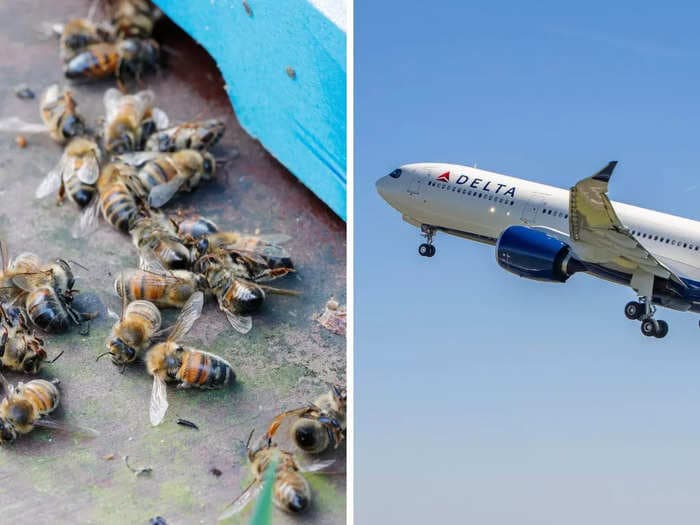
[496,226,585,283]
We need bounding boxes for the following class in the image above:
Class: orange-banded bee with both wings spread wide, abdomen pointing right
[146,292,236,426]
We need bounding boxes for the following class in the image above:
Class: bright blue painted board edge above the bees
[156,0,346,219]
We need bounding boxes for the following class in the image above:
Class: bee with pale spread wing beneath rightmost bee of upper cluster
[120,149,216,208]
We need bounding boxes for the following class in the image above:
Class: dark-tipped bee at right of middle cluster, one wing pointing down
[194,254,298,334]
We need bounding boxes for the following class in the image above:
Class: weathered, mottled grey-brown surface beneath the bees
[0,0,345,524]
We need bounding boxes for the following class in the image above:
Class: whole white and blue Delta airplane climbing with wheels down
[376,161,700,338]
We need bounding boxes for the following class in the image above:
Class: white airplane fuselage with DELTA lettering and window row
[377,163,700,281]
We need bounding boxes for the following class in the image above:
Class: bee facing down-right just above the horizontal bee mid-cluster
[130,210,190,269]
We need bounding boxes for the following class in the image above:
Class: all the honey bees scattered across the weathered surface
[0,0,347,518]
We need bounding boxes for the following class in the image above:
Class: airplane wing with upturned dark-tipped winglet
[569,161,686,287]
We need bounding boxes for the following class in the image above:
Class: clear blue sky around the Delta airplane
[355,0,700,525]
